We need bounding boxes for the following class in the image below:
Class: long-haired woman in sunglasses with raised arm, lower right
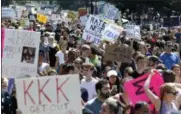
[144,70,181,114]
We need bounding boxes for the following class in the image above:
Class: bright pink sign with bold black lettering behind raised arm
[124,72,164,110]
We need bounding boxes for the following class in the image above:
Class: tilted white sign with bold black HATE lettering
[82,15,108,45]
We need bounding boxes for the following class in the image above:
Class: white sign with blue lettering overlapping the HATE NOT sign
[102,24,124,43]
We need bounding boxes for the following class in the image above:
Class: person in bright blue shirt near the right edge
[159,41,180,69]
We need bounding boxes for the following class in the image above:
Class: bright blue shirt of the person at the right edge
[160,53,180,69]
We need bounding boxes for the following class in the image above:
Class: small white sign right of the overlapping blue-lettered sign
[126,25,141,40]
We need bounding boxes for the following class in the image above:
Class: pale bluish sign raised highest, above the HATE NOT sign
[104,4,119,20]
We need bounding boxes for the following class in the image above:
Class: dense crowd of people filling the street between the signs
[1,2,181,114]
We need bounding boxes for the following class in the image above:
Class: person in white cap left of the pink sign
[107,70,120,95]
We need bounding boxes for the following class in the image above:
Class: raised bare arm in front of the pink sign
[144,71,161,111]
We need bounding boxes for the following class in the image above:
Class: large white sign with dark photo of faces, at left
[2,29,40,78]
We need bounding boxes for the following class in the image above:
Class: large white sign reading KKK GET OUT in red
[15,75,82,114]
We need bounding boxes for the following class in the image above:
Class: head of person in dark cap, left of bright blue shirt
[148,55,162,68]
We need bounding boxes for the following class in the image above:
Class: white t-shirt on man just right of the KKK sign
[81,78,98,100]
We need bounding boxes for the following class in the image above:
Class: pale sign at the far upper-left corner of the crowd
[2,8,16,19]
